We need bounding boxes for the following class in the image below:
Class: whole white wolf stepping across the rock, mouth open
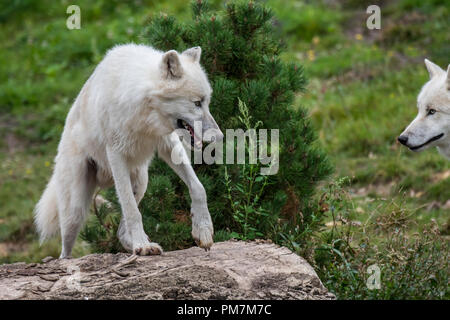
[35,44,223,258]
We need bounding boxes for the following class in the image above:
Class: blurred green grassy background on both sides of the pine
[0,0,450,295]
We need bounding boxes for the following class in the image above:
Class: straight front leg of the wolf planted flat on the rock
[107,148,162,255]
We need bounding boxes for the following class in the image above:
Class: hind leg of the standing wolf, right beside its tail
[57,157,96,258]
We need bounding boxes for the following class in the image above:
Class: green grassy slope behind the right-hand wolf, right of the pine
[269,0,450,225]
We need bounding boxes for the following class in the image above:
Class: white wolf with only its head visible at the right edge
[398,59,450,159]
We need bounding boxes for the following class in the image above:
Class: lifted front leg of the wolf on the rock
[158,133,214,250]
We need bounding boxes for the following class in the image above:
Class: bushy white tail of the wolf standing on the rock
[34,174,59,243]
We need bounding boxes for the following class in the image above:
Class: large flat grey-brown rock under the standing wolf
[0,241,335,300]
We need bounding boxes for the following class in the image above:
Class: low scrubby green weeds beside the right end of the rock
[310,180,450,300]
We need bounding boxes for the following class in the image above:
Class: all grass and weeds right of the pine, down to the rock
[273,1,450,299]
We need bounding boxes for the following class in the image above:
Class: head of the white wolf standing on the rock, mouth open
[153,47,223,147]
